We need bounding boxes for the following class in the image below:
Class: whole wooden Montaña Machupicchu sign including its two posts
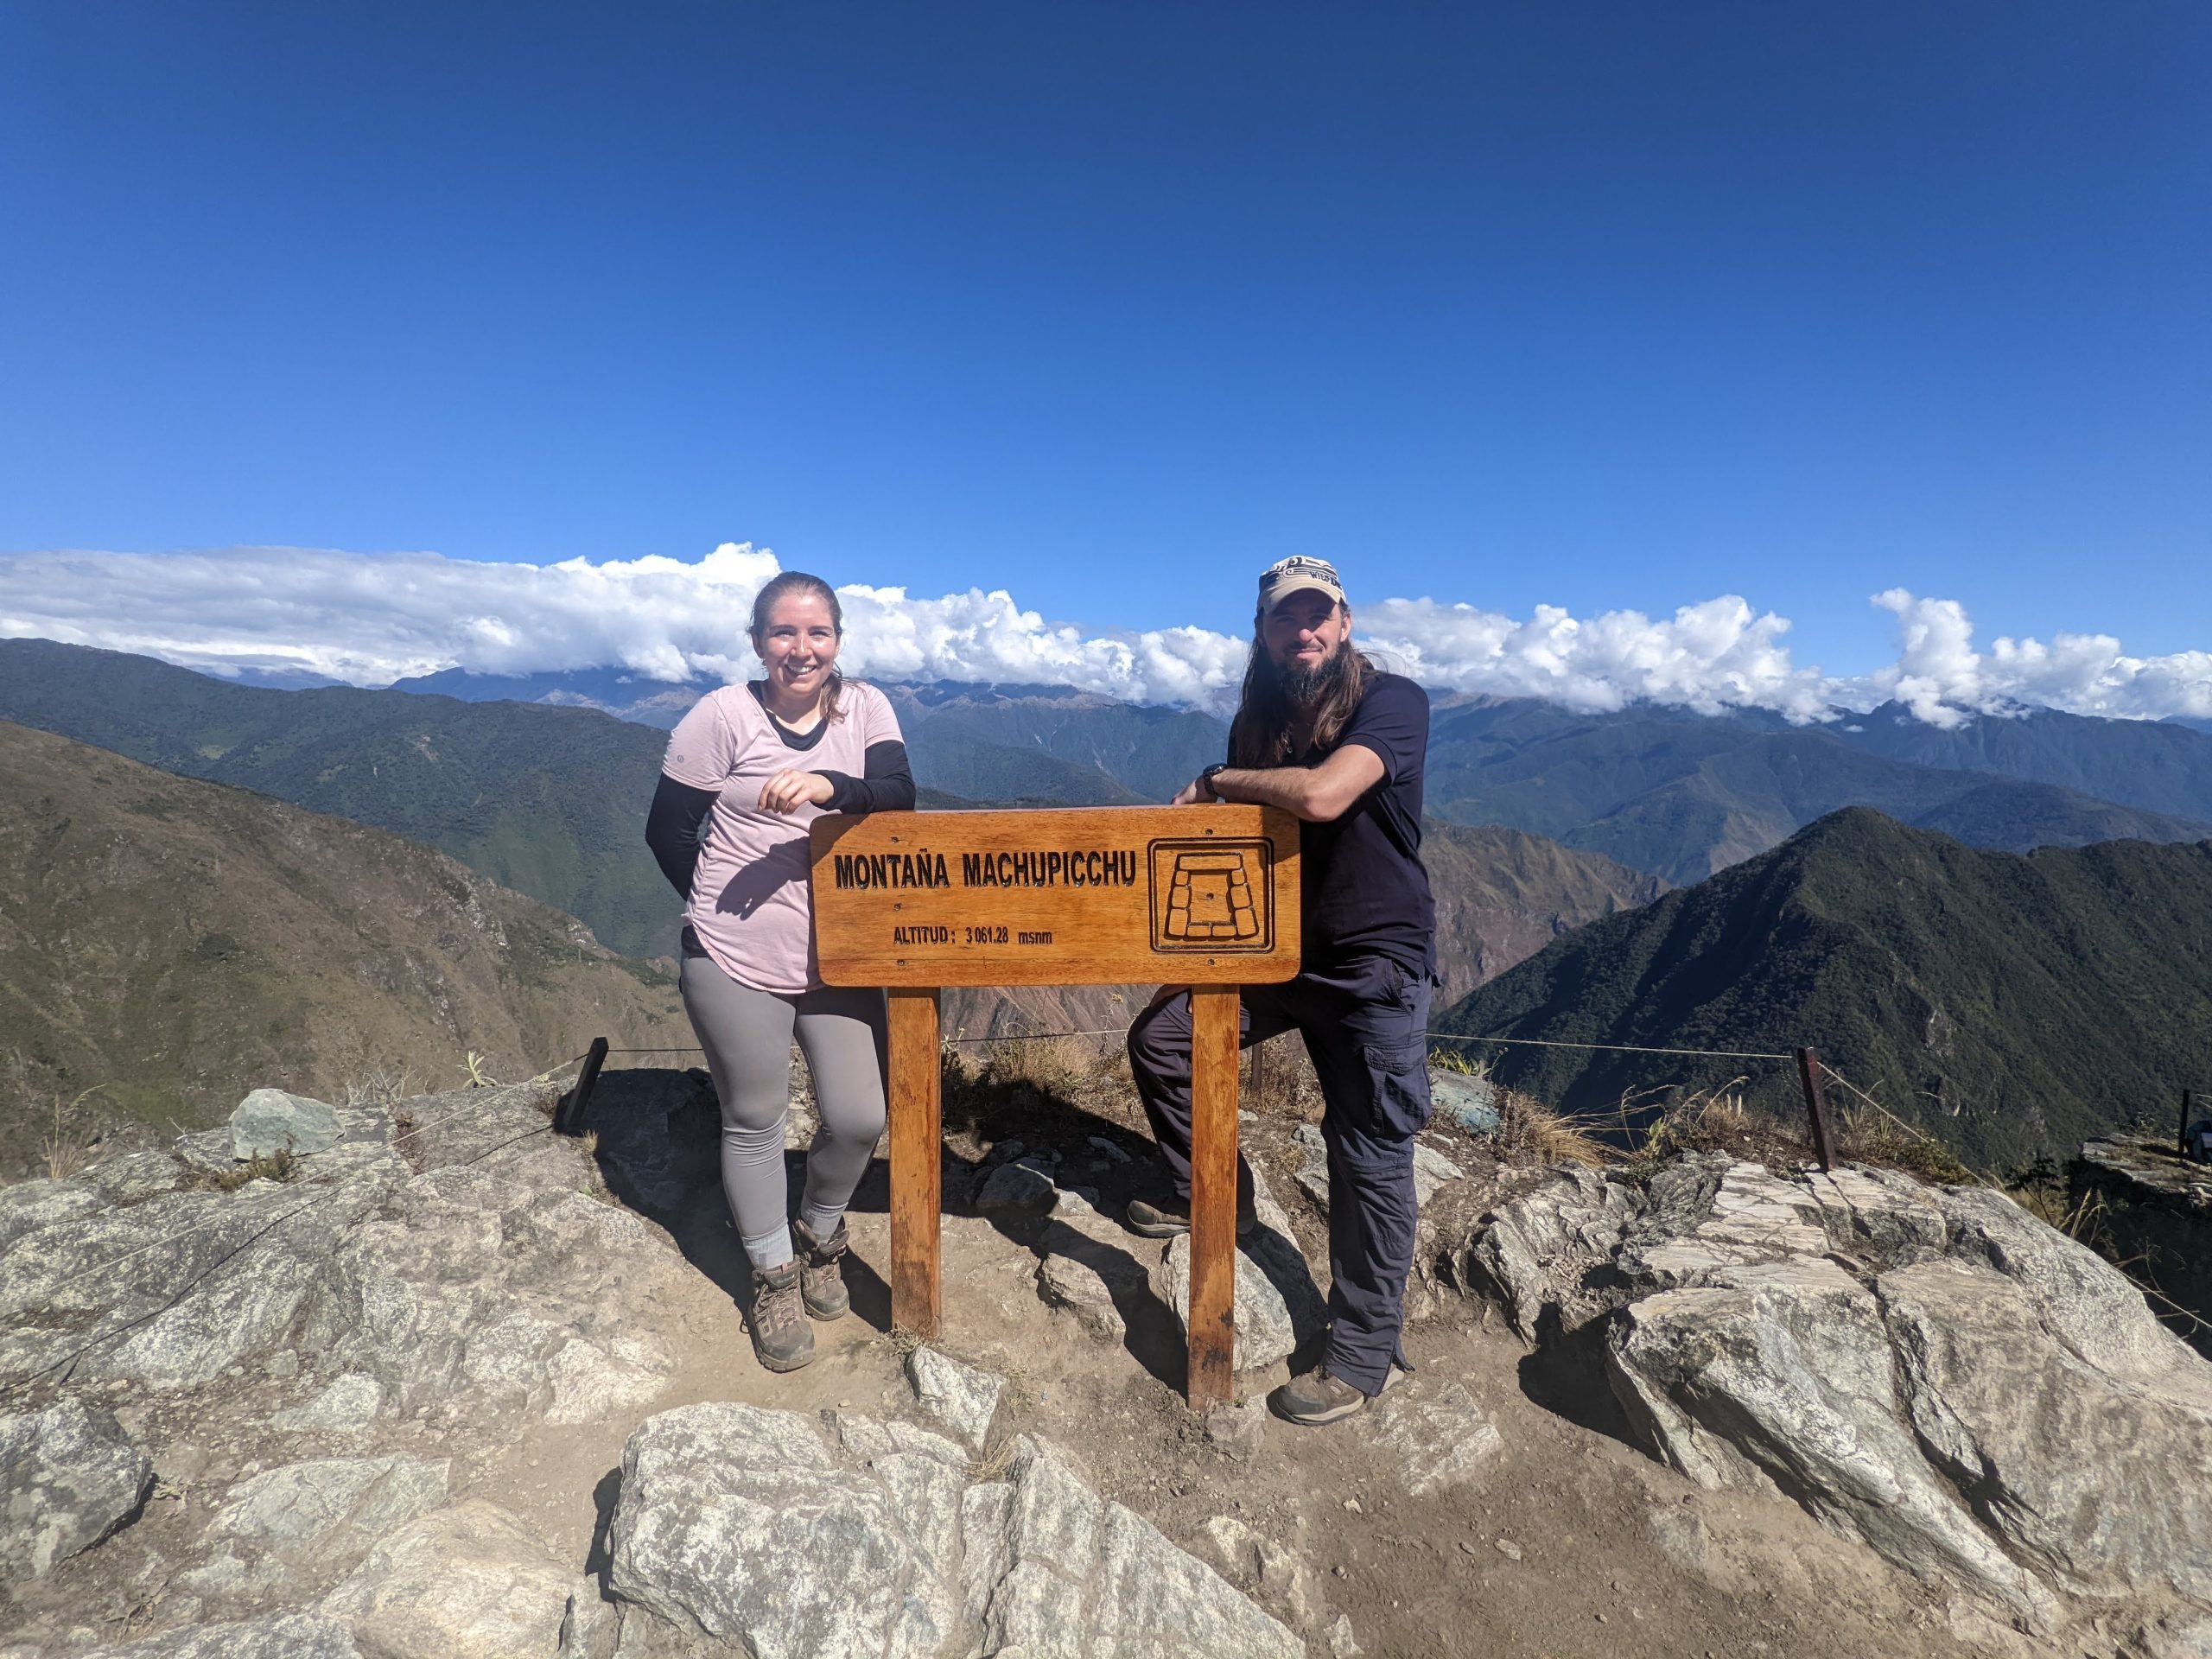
[812,805,1299,1409]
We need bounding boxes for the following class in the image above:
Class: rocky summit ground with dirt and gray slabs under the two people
[0,1071,2212,1659]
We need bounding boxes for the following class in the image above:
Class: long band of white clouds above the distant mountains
[0,542,2212,726]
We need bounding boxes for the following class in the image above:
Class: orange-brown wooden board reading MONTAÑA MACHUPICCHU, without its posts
[812,805,1299,987]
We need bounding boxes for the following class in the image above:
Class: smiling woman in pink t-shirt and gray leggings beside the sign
[646,570,913,1371]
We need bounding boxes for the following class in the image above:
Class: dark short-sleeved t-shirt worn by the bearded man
[1299,675,1435,973]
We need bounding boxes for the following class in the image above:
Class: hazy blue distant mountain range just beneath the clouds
[372,654,2212,885]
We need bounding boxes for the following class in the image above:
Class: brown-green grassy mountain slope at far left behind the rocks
[0,723,690,1174]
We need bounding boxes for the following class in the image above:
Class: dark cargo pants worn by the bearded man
[1128,956,1429,1395]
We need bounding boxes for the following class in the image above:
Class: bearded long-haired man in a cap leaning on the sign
[1128,557,1435,1425]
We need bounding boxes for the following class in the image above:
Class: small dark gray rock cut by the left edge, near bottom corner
[0,1400,153,1577]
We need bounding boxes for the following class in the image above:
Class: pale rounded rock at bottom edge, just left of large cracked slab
[321,1500,575,1659]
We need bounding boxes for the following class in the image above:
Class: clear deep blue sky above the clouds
[0,0,2212,703]
